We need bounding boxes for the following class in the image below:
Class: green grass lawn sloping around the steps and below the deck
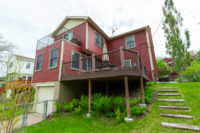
[18,83,200,133]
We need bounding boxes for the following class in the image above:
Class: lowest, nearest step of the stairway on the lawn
[161,122,200,131]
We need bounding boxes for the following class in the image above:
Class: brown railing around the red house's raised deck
[62,47,148,76]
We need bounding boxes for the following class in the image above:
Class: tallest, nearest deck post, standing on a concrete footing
[124,76,133,122]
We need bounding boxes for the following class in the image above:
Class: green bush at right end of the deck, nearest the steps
[144,86,153,104]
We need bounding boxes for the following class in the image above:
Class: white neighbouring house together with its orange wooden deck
[5,55,34,97]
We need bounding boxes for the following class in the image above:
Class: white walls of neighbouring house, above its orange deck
[7,55,34,81]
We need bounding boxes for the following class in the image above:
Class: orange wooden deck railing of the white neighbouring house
[5,80,31,89]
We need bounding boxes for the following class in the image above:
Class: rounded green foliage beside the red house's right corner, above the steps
[156,59,172,78]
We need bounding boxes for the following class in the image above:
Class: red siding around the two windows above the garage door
[32,40,61,83]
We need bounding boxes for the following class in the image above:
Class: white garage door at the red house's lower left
[36,87,54,114]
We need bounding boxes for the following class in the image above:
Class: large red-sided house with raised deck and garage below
[32,16,158,118]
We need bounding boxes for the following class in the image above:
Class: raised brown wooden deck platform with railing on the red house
[61,48,150,81]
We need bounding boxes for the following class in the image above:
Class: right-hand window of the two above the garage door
[50,48,58,68]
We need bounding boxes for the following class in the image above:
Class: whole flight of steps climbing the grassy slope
[157,87,200,131]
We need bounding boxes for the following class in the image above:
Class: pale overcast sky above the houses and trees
[0,0,200,58]
